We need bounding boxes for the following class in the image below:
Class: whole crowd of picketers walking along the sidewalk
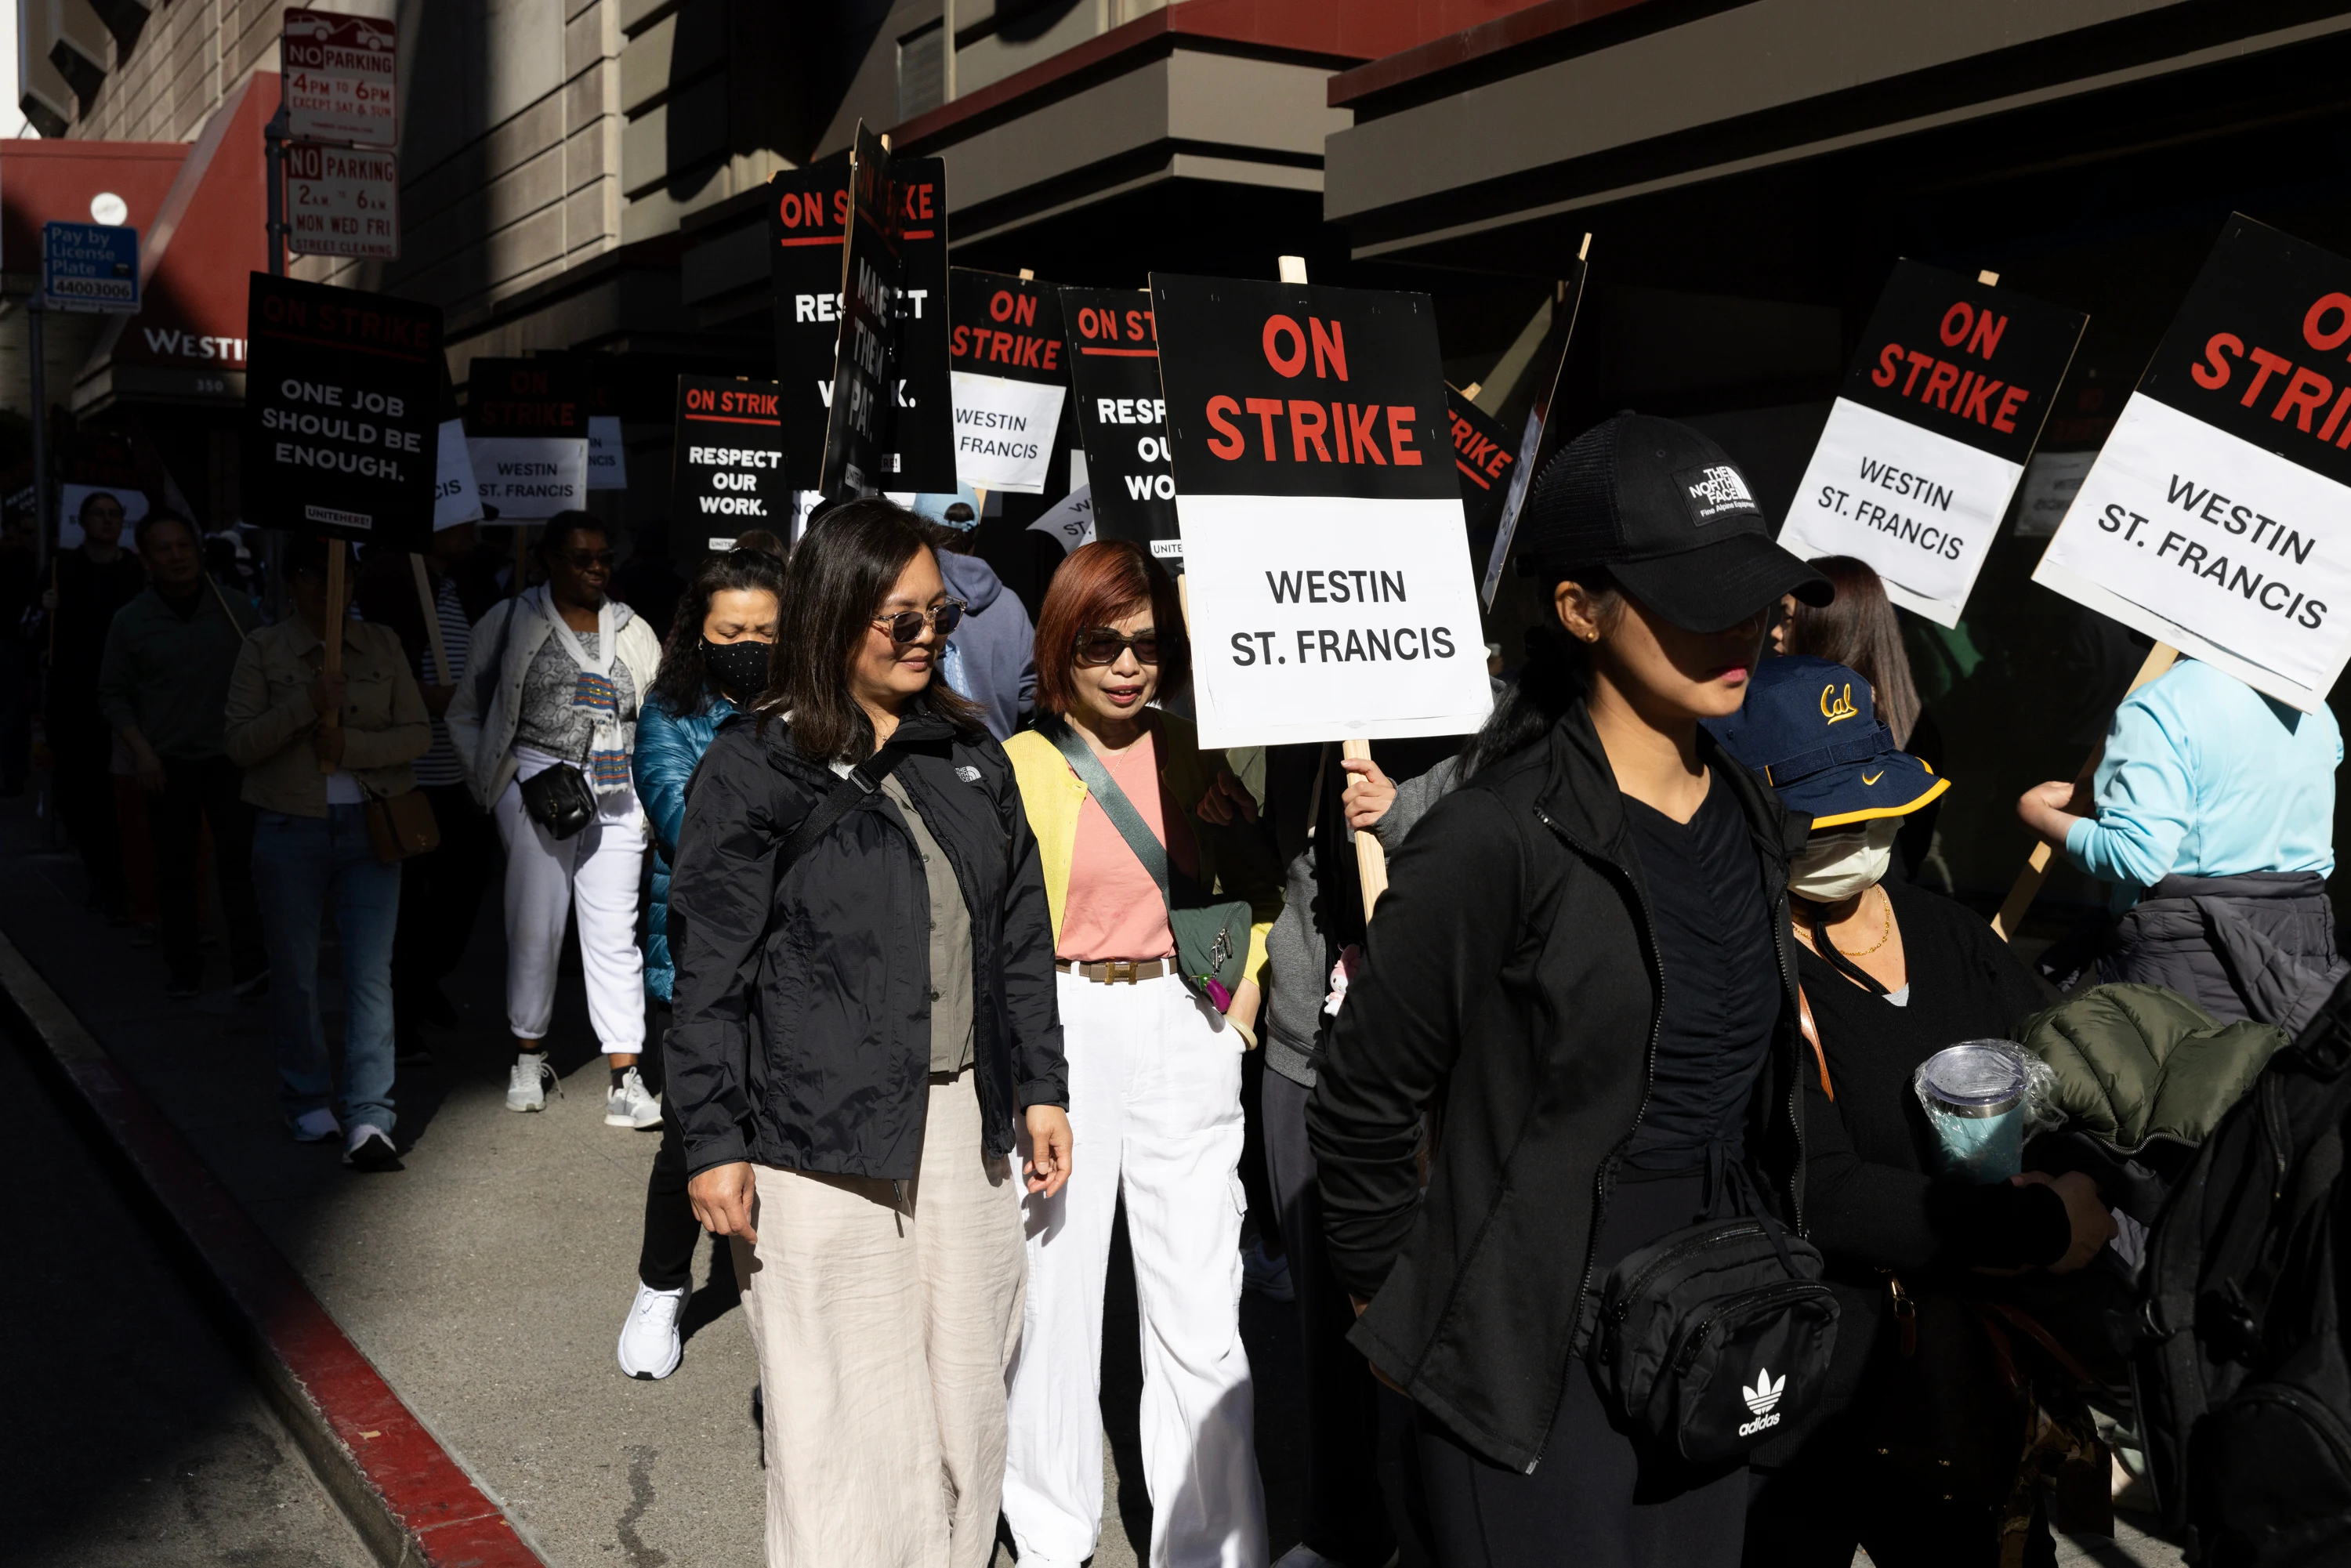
[9,416,2344,1568]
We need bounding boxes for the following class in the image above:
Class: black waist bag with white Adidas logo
[1594,1215,1836,1465]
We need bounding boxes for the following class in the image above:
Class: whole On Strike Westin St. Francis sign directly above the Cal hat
[1780,261,2090,625]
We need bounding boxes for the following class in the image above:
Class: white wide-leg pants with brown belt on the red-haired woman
[1004,973,1265,1568]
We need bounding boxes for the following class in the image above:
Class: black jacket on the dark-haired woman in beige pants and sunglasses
[663,712,1070,1180]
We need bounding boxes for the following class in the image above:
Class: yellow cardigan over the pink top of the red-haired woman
[1004,710,1281,985]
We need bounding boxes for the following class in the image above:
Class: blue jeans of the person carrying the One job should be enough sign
[254,806,400,1133]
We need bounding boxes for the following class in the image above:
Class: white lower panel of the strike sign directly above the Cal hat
[1780,397,2024,625]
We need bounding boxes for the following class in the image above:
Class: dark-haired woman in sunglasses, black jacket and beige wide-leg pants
[665,501,1070,1568]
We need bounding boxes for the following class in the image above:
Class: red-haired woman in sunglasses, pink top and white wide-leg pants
[1004,541,1281,1568]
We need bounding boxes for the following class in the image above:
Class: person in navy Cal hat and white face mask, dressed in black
[1712,656,2114,1568]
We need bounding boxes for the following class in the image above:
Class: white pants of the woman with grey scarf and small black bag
[496,764,651,1056]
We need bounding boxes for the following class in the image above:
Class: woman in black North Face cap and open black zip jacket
[1307,414,1829,1568]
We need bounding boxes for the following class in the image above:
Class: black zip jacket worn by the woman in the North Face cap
[1307,703,1810,1472]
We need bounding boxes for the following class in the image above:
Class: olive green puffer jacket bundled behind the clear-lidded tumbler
[2024,985,2285,1157]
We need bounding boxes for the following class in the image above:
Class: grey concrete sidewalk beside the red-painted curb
[0,802,1302,1568]
